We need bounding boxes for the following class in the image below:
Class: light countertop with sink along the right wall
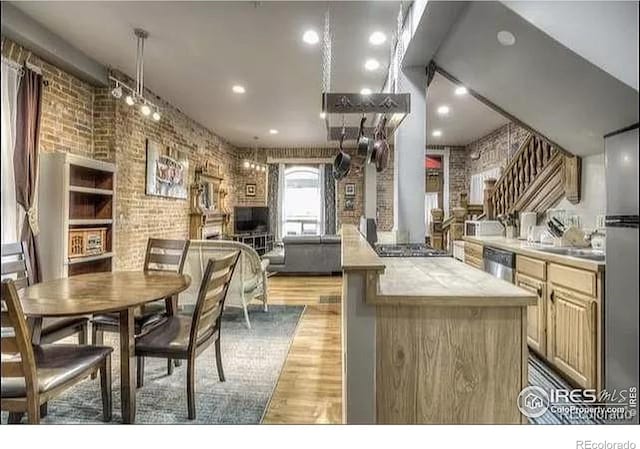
[463,236,606,271]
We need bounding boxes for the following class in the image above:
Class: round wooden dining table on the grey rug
[21,271,191,423]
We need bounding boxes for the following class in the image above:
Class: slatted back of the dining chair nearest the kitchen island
[189,251,240,350]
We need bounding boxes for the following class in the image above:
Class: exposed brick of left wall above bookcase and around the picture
[2,37,239,270]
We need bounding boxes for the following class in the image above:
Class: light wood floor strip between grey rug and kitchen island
[263,276,342,424]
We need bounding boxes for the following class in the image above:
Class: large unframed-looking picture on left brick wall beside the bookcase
[145,139,189,200]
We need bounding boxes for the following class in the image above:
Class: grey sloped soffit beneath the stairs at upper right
[432,2,638,155]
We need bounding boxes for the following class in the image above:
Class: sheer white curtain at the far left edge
[0,60,19,243]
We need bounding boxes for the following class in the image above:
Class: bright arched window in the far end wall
[282,165,322,235]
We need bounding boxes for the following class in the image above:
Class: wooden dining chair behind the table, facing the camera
[91,238,189,378]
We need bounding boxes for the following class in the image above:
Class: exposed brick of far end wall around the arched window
[236,148,393,231]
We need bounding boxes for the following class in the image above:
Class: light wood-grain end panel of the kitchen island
[376,306,528,424]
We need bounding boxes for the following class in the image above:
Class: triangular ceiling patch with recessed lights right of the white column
[427,73,509,146]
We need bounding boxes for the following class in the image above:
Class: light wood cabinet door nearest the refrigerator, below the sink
[547,283,597,388]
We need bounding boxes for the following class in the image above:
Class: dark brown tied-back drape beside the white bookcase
[13,66,42,282]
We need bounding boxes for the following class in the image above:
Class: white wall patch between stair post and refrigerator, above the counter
[556,153,607,229]
